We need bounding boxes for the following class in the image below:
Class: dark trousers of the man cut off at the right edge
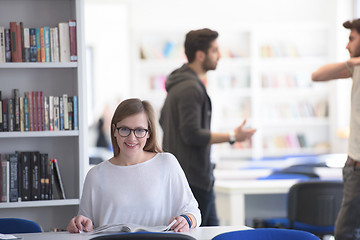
[335,157,360,240]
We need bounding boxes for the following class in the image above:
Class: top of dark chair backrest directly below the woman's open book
[91,232,196,240]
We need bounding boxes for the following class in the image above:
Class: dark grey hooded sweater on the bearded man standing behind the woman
[160,64,214,191]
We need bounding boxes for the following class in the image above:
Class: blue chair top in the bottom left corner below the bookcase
[0,218,42,234]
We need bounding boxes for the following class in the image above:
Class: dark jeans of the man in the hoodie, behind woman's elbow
[190,186,219,226]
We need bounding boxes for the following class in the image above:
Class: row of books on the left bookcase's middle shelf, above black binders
[0,89,79,132]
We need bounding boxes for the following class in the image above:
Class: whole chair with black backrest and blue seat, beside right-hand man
[264,181,343,237]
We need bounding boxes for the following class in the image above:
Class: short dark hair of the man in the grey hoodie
[184,28,219,63]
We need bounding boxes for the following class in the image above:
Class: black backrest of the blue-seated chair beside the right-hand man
[288,181,343,227]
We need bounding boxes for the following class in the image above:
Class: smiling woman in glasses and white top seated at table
[67,99,201,233]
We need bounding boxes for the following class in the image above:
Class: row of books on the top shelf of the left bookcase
[0,20,77,63]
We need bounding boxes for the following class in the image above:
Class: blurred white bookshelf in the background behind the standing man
[133,22,335,160]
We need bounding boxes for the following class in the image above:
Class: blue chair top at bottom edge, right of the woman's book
[212,228,319,240]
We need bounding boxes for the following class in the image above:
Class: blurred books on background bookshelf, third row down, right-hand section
[263,100,329,119]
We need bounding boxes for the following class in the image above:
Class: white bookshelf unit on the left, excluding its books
[0,0,88,231]
